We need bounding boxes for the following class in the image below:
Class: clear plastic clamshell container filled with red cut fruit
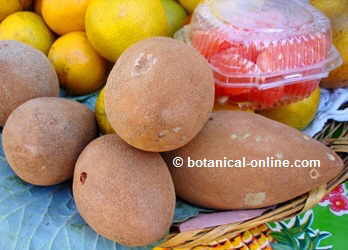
[184,0,342,109]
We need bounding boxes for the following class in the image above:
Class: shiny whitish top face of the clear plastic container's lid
[193,0,330,41]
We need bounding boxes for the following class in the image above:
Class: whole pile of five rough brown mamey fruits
[0,37,343,246]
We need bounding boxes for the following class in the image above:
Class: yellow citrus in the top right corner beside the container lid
[310,0,348,18]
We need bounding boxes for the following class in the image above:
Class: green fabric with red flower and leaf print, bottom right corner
[269,182,348,250]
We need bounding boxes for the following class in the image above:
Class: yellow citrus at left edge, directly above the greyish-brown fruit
[0,11,54,54]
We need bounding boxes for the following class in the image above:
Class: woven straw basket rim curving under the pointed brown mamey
[159,122,348,249]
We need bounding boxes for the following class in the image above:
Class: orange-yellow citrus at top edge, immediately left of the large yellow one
[41,0,89,35]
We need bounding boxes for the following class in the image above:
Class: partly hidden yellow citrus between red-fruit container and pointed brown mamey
[259,88,320,129]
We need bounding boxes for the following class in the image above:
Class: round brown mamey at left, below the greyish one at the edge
[3,97,97,186]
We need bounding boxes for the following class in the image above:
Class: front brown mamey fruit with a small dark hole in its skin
[73,134,175,246]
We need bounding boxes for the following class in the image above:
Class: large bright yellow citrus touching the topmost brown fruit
[86,0,168,62]
